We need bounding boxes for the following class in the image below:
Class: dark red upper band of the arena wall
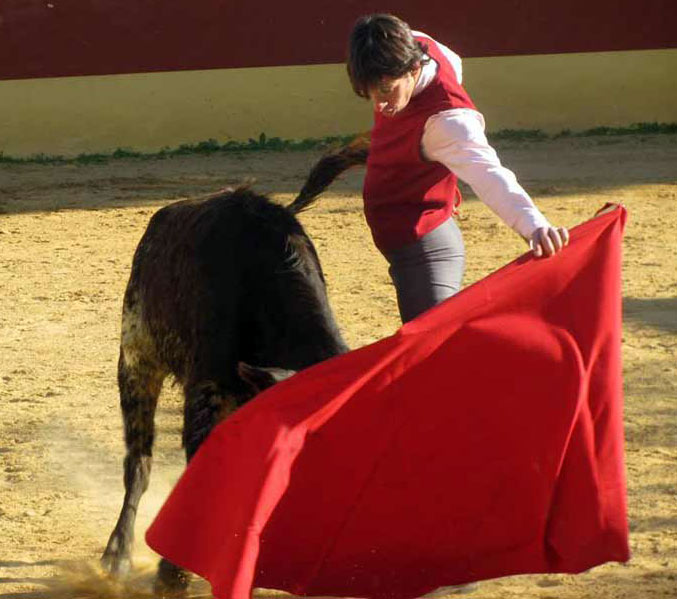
[0,0,677,79]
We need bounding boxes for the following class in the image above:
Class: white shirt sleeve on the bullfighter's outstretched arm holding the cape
[421,108,551,239]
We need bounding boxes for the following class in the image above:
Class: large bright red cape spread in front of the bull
[146,207,628,599]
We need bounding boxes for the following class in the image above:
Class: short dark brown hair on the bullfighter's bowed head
[346,14,428,98]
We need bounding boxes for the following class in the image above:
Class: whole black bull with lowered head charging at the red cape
[101,144,367,590]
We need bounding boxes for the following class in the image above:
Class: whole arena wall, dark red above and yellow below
[0,0,677,156]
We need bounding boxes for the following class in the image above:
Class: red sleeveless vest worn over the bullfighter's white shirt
[363,37,475,250]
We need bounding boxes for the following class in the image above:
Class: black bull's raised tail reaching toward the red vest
[288,136,369,214]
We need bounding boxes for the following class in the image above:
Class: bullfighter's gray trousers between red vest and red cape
[383,218,465,323]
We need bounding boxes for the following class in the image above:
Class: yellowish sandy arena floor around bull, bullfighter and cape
[0,135,677,599]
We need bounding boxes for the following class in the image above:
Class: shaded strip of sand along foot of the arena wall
[0,135,677,215]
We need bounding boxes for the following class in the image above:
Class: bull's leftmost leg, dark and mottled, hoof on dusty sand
[101,348,165,575]
